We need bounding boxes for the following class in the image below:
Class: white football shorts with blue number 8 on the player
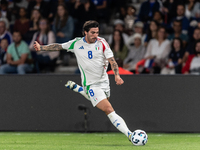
[84,80,110,107]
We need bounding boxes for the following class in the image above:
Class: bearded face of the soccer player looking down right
[85,27,99,43]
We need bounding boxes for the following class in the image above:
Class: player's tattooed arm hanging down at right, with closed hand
[108,57,124,85]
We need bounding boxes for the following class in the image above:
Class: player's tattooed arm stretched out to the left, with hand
[33,41,63,51]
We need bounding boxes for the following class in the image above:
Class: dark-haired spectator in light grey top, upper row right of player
[124,6,136,35]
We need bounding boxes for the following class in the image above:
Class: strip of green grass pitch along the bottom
[0,132,200,150]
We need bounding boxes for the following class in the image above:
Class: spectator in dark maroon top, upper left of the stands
[14,7,30,39]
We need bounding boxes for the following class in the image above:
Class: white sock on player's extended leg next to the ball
[108,111,131,137]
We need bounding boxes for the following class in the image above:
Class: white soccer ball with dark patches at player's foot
[131,129,148,146]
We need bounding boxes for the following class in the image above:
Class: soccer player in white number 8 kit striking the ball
[34,21,132,143]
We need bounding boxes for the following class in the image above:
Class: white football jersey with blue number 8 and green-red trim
[62,37,113,86]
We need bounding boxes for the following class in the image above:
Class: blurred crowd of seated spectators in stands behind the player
[0,0,200,74]
